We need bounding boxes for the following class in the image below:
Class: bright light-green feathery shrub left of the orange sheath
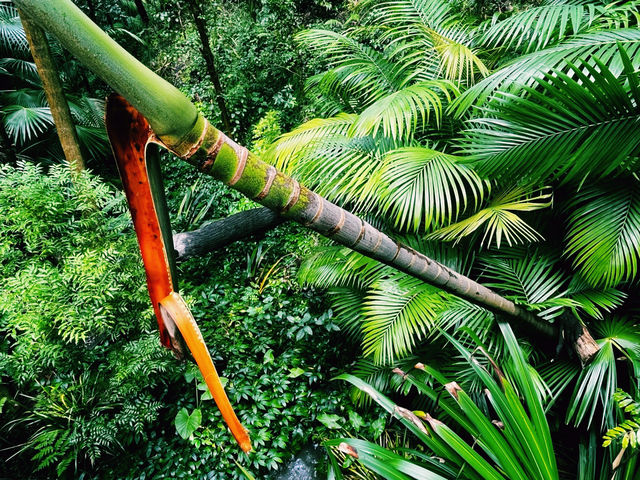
[0,162,173,476]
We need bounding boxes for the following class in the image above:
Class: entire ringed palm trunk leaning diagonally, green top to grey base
[14,0,598,363]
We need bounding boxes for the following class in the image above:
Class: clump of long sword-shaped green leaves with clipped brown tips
[325,324,559,480]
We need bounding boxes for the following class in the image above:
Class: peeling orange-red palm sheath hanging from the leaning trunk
[106,95,251,452]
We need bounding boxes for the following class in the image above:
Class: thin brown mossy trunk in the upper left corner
[19,10,84,172]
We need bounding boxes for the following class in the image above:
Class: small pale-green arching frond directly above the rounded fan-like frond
[349,80,458,141]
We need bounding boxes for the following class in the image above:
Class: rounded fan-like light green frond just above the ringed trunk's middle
[378,147,485,232]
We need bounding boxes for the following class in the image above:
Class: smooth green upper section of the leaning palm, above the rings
[14,0,198,147]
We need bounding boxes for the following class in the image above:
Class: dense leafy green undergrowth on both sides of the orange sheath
[0,164,384,478]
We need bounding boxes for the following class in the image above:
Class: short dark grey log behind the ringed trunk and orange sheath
[173,208,285,259]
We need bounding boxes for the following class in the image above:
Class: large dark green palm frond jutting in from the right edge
[463,50,640,182]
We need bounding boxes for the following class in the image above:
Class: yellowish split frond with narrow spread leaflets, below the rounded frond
[427,187,551,248]
